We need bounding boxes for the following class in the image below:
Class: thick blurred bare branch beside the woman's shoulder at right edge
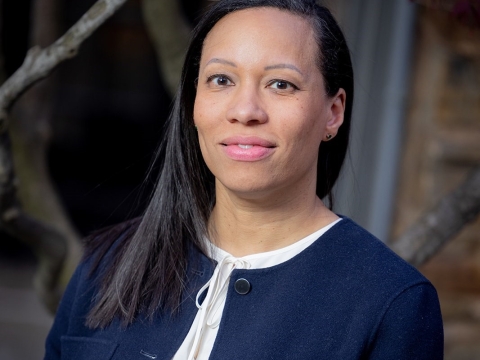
[391,166,480,266]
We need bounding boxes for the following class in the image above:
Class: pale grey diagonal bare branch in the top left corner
[0,0,126,114]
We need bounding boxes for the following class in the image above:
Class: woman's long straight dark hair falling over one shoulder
[87,0,353,328]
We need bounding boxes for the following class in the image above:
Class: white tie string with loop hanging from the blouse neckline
[187,256,250,360]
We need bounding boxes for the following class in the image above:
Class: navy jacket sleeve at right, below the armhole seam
[368,283,443,360]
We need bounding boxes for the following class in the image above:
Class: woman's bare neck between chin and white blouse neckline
[209,184,338,257]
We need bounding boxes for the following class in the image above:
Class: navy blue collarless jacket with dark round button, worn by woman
[45,219,443,360]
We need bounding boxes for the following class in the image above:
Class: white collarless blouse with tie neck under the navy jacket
[172,219,341,360]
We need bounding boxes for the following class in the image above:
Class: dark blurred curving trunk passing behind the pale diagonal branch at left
[8,0,82,312]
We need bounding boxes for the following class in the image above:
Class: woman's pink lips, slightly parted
[220,136,276,161]
